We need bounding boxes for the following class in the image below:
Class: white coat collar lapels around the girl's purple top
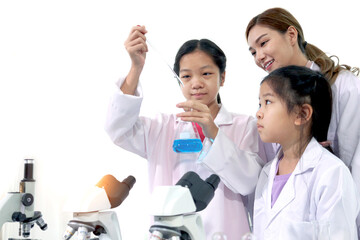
[262,138,323,226]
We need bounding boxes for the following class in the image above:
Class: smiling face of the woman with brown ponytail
[248,25,295,72]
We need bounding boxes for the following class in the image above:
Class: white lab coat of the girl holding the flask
[105,78,267,240]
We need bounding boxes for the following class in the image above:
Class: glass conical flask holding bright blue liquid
[173,120,202,153]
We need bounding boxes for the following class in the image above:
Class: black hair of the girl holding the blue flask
[174,39,226,103]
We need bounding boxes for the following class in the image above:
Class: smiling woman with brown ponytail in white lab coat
[246,8,360,189]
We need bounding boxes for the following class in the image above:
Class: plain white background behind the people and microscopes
[0,0,360,240]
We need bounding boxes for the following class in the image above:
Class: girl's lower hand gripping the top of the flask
[176,100,219,139]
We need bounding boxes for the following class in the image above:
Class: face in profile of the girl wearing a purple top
[256,82,297,145]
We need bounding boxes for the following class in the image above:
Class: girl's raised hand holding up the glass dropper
[124,25,148,69]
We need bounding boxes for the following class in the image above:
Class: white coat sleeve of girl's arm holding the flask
[201,124,263,195]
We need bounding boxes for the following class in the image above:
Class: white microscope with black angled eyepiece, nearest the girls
[149,171,220,240]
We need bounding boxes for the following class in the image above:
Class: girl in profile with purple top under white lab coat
[254,66,360,240]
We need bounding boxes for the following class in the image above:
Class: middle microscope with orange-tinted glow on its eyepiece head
[63,175,136,240]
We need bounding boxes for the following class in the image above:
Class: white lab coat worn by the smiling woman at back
[310,62,360,190]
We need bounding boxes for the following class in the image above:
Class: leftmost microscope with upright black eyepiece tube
[0,159,47,240]
